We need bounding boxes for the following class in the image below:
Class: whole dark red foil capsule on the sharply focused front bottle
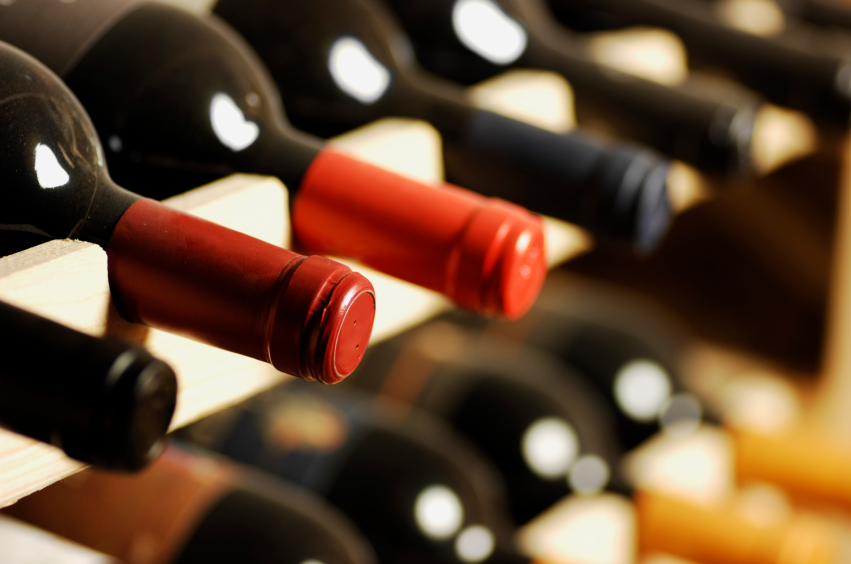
[106,199,375,384]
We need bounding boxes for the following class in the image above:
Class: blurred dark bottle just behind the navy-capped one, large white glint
[350,0,776,175]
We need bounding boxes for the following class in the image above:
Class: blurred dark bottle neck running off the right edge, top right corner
[549,0,851,128]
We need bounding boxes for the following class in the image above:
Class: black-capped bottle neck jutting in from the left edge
[0,302,177,470]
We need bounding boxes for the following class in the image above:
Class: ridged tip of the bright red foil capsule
[447,198,547,319]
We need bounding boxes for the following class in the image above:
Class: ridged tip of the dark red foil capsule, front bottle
[268,255,375,384]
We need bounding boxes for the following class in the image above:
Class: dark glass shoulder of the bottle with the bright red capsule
[60,3,318,192]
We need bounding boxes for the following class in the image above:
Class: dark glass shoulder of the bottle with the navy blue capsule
[215,0,469,135]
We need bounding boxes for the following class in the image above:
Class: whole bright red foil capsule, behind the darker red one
[292,149,547,319]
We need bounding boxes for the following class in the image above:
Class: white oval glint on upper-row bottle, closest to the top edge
[452,0,528,65]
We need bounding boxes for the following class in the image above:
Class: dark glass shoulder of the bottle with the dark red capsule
[0,45,132,246]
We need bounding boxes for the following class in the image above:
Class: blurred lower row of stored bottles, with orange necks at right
[7,280,851,564]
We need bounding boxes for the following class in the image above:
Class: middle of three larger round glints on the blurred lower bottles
[521,417,579,479]
